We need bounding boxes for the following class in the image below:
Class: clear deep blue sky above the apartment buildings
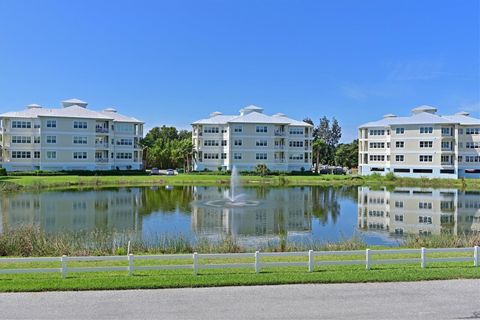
[0,0,480,141]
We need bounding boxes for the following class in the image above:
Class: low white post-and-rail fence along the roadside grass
[0,246,480,278]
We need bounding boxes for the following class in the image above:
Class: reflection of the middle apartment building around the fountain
[191,187,312,237]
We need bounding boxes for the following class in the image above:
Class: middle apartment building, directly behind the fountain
[192,105,313,171]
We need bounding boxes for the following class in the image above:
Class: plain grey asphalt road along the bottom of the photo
[0,280,480,320]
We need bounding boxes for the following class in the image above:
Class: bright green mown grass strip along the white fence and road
[0,253,480,292]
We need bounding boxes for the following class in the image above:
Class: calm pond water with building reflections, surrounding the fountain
[0,187,480,246]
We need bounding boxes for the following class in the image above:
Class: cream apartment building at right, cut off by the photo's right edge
[358,106,480,178]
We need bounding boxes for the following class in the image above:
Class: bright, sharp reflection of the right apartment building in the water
[358,187,480,236]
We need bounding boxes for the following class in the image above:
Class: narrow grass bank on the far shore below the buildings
[0,174,480,191]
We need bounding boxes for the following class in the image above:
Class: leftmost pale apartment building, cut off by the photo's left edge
[0,99,143,171]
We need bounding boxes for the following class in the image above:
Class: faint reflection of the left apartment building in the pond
[0,188,142,233]
